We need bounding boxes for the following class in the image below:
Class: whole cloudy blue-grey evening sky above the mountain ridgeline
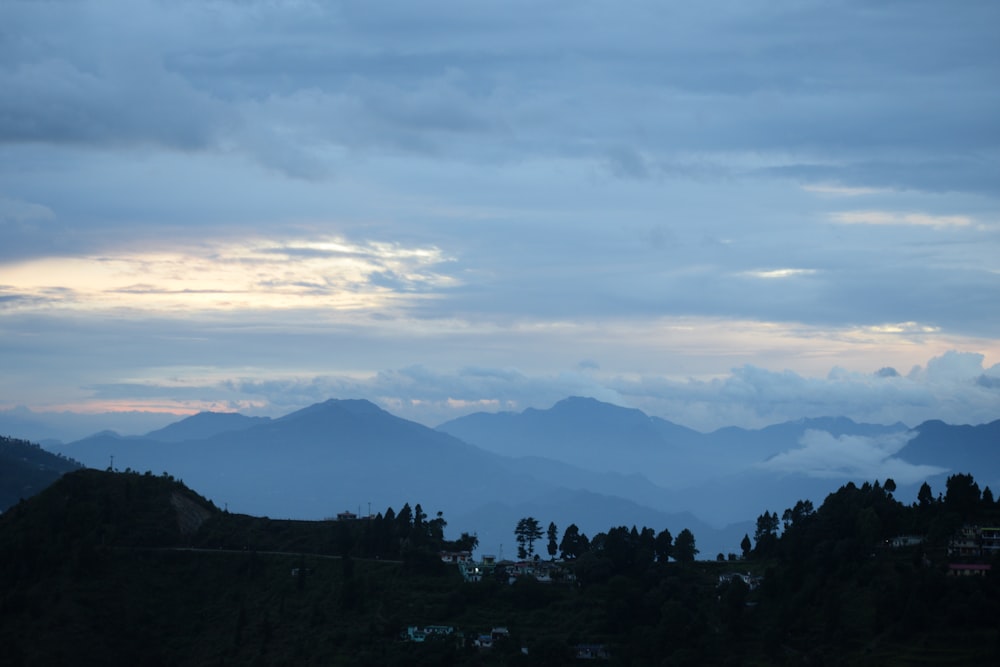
[0,0,1000,444]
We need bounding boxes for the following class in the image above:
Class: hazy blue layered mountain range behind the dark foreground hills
[21,397,1000,557]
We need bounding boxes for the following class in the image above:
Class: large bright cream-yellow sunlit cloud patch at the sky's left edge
[3,237,457,313]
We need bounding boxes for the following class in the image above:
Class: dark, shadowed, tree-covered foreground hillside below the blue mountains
[0,470,1000,665]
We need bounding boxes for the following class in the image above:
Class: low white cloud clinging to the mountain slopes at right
[757,430,947,484]
